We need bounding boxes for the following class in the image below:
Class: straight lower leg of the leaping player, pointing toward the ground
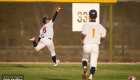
[43,38,60,66]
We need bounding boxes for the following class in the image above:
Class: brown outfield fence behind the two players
[0,2,140,62]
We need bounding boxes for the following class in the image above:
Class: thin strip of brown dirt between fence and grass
[0,62,140,64]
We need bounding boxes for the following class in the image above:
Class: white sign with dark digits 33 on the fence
[72,3,100,31]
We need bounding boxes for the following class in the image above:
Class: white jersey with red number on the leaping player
[39,20,54,38]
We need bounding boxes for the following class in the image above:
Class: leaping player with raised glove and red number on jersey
[29,7,62,66]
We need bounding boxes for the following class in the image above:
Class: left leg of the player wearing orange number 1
[82,45,91,80]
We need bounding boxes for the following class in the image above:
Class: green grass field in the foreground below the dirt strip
[0,64,140,80]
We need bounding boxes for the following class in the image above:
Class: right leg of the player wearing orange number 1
[89,46,99,80]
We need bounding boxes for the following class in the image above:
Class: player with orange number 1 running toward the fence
[81,9,106,80]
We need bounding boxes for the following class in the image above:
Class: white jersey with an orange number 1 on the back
[82,22,106,44]
